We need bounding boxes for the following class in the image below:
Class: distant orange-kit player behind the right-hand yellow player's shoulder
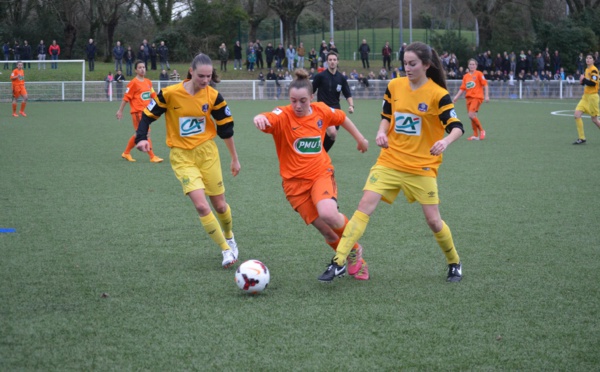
[452,58,490,141]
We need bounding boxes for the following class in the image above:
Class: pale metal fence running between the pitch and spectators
[0,80,583,102]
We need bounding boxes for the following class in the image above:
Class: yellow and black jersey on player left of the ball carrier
[136,80,233,150]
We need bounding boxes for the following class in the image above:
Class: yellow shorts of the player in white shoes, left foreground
[170,140,225,196]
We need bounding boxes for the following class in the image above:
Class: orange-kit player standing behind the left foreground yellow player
[117,60,163,163]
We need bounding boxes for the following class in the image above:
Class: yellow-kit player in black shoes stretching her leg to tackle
[319,42,464,282]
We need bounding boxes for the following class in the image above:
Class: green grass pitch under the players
[0,100,600,371]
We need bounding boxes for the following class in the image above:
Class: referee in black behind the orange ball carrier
[313,51,354,151]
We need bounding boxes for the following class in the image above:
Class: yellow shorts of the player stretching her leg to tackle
[363,165,440,204]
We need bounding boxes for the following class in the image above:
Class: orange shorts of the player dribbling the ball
[283,169,337,225]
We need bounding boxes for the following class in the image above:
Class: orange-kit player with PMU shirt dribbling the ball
[254,69,369,280]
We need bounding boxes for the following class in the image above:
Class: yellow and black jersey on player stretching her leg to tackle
[377,77,464,177]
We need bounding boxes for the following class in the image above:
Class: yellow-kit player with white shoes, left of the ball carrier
[135,53,240,268]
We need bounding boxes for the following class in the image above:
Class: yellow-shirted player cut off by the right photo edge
[573,54,600,145]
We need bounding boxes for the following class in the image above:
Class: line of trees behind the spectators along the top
[0,0,600,72]
